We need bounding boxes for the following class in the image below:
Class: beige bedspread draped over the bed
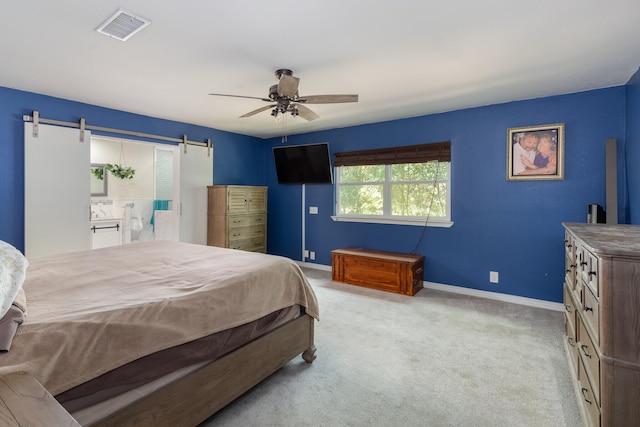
[0,241,318,395]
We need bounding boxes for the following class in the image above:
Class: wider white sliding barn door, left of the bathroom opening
[24,123,91,257]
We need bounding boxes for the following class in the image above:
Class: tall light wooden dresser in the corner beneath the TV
[207,185,267,253]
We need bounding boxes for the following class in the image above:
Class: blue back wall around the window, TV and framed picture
[264,87,625,302]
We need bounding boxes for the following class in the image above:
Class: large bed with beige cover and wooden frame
[0,241,318,426]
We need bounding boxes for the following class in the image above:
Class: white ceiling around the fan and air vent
[0,0,640,138]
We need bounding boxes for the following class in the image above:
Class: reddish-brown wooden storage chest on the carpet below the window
[331,248,424,295]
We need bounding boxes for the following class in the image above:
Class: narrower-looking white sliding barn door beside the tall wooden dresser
[180,144,213,245]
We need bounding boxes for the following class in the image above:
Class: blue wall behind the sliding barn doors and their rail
[0,87,264,250]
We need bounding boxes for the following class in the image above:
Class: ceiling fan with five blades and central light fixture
[209,68,358,120]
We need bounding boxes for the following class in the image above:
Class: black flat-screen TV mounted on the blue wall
[273,142,333,184]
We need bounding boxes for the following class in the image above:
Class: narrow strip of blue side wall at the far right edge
[625,69,640,224]
